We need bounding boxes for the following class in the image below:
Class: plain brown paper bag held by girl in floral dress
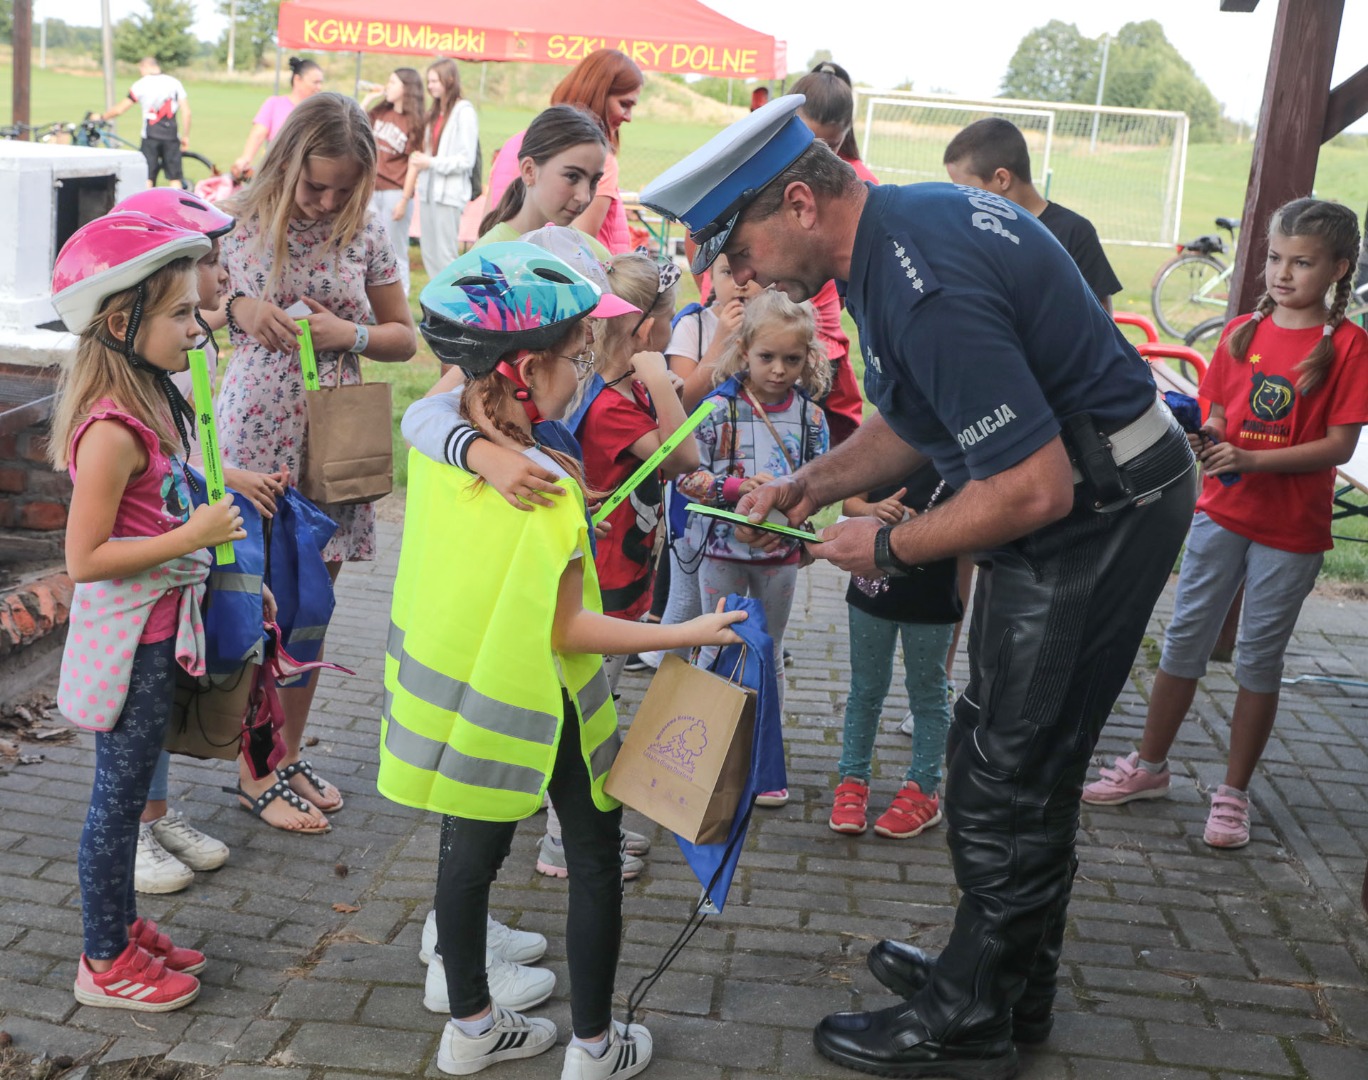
[298,364,394,506]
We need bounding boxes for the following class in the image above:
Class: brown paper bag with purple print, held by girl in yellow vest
[605,656,755,843]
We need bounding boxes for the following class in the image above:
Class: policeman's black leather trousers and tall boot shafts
[912,462,1197,1042]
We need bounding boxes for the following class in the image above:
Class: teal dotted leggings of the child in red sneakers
[837,608,955,795]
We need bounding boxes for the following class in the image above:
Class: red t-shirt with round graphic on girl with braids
[1197,315,1368,553]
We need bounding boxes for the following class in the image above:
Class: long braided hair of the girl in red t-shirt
[1226,198,1358,394]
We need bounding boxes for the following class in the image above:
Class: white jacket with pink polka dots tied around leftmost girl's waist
[57,550,209,731]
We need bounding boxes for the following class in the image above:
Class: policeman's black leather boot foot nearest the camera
[813,1003,1018,1080]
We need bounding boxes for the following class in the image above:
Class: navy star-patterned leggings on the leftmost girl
[77,638,176,960]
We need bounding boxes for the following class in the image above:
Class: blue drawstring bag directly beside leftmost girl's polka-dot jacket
[186,465,265,675]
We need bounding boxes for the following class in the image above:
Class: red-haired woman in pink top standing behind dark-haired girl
[487,49,644,255]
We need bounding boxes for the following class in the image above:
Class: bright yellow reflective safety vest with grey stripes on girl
[378,450,620,821]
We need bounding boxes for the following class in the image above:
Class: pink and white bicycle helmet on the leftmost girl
[52,211,213,331]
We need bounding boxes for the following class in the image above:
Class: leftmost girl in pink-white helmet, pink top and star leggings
[49,212,246,1012]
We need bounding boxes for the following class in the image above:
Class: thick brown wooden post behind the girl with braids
[1226,0,1345,319]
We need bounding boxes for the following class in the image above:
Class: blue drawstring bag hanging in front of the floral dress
[265,487,338,687]
